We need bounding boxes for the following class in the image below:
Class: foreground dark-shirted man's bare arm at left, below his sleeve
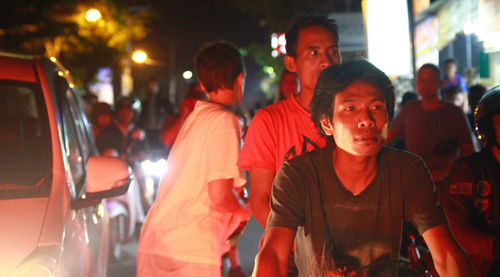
[252,227,296,277]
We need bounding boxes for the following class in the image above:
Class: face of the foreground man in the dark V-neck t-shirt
[323,81,388,157]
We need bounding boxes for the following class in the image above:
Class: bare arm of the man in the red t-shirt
[250,167,274,229]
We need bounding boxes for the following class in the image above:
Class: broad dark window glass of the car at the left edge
[0,81,51,193]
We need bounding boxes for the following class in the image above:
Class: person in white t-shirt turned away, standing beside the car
[137,41,250,277]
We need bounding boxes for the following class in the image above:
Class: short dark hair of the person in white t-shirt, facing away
[195,41,244,92]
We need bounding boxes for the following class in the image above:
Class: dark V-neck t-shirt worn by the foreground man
[267,145,447,276]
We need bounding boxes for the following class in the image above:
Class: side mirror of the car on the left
[72,156,133,208]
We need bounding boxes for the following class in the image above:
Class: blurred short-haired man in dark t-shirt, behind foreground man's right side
[387,64,474,182]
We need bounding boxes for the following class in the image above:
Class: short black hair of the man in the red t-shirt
[285,15,339,58]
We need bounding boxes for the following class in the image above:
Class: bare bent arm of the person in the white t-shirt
[208,179,251,220]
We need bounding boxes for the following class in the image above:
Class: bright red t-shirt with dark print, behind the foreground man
[238,97,326,173]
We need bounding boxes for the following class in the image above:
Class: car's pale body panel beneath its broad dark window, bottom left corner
[0,197,48,272]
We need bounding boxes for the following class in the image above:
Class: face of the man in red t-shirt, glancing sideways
[287,26,341,90]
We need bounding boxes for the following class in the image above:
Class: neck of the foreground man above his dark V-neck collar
[333,147,377,195]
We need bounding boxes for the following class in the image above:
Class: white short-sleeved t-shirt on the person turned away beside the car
[137,101,246,266]
